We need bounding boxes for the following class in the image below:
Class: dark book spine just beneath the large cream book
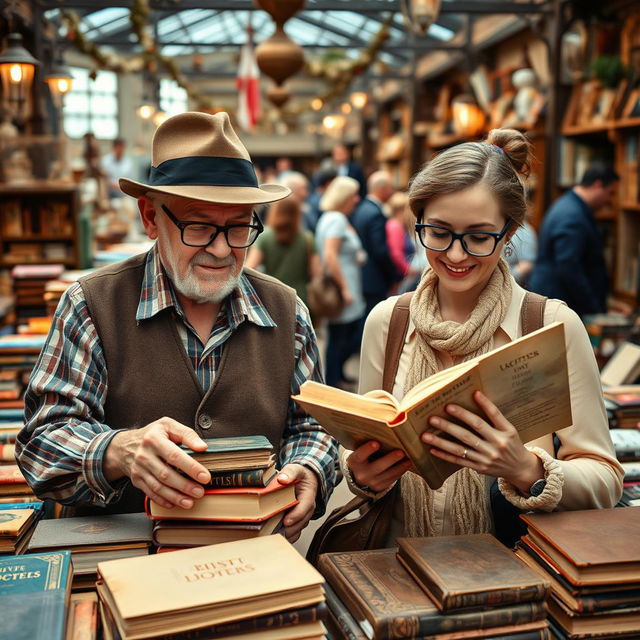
[148,602,327,640]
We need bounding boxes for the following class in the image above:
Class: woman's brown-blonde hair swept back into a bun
[409,129,531,226]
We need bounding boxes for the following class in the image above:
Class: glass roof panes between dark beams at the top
[45,0,464,66]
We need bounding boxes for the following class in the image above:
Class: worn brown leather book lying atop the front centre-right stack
[397,533,550,612]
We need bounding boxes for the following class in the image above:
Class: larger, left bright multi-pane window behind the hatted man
[64,67,118,140]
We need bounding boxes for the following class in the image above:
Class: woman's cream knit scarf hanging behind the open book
[401,260,511,536]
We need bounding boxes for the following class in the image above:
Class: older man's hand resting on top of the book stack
[103,417,211,509]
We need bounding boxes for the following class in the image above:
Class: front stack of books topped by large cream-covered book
[98,536,326,640]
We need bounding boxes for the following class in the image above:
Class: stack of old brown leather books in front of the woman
[318,535,551,640]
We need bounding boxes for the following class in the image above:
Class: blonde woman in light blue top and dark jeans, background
[316,176,365,386]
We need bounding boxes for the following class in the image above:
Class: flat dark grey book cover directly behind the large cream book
[29,513,153,553]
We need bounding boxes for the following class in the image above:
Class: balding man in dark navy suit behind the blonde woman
[350,171,401,317]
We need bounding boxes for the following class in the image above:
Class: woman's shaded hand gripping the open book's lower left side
[347,440,411,493]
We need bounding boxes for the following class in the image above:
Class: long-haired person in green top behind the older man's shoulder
[246,196,320,304]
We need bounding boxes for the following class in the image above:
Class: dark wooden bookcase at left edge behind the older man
[0,182,85,269]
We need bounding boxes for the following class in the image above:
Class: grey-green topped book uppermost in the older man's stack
[183,436,273,471]
